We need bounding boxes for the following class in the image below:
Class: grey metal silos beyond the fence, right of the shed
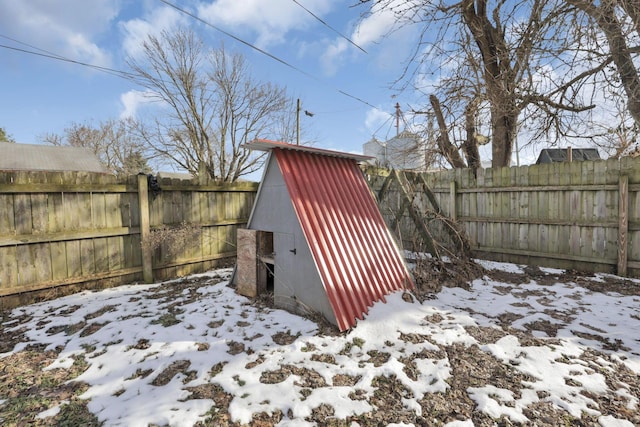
[362,131,428,170]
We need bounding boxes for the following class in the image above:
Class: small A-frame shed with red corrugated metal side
[235,140,414,330]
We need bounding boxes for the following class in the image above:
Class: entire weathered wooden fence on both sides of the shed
[6,158,640,307]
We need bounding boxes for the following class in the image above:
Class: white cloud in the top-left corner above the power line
[0,0,119,66]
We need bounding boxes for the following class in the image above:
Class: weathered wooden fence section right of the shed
[366,158,640,277]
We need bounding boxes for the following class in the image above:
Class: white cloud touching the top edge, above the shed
[198,0,335,48]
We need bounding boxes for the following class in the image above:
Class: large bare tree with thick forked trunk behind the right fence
[364,0,596,167]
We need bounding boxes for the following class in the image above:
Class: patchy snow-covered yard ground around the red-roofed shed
[0,261,640,427]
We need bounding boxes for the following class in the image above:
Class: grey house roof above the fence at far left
[0,142,109,173]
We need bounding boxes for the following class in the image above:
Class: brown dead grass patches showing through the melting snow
[0,265,640,427]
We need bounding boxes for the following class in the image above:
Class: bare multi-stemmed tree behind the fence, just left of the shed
[128,30,291,182]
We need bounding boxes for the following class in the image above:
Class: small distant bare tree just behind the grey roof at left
[40,119,151,175]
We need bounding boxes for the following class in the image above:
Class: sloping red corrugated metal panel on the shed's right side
[273,147,413,330]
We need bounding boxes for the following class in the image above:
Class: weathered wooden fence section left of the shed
[0,172,257,307]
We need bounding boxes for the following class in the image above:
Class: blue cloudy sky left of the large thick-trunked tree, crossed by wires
[0,0,419,162]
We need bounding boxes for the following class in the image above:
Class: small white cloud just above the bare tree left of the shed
[121,7,186,58]
